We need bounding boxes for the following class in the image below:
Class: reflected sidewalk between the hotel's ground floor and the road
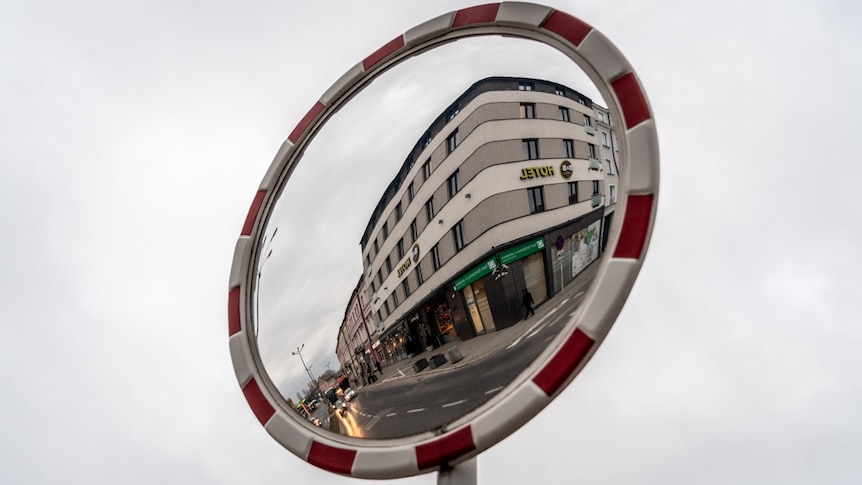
[369,264,599,386]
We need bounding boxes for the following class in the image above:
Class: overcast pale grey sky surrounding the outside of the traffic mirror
[0,0,862,484]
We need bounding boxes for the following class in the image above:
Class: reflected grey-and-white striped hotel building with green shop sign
[338,77,617,368]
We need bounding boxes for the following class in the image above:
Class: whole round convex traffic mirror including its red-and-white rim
[229,3,658,478]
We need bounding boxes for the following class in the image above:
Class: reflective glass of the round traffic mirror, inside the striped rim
[254,36,621,439]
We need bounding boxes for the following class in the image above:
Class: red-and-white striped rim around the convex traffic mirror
[228,2,659,478]
